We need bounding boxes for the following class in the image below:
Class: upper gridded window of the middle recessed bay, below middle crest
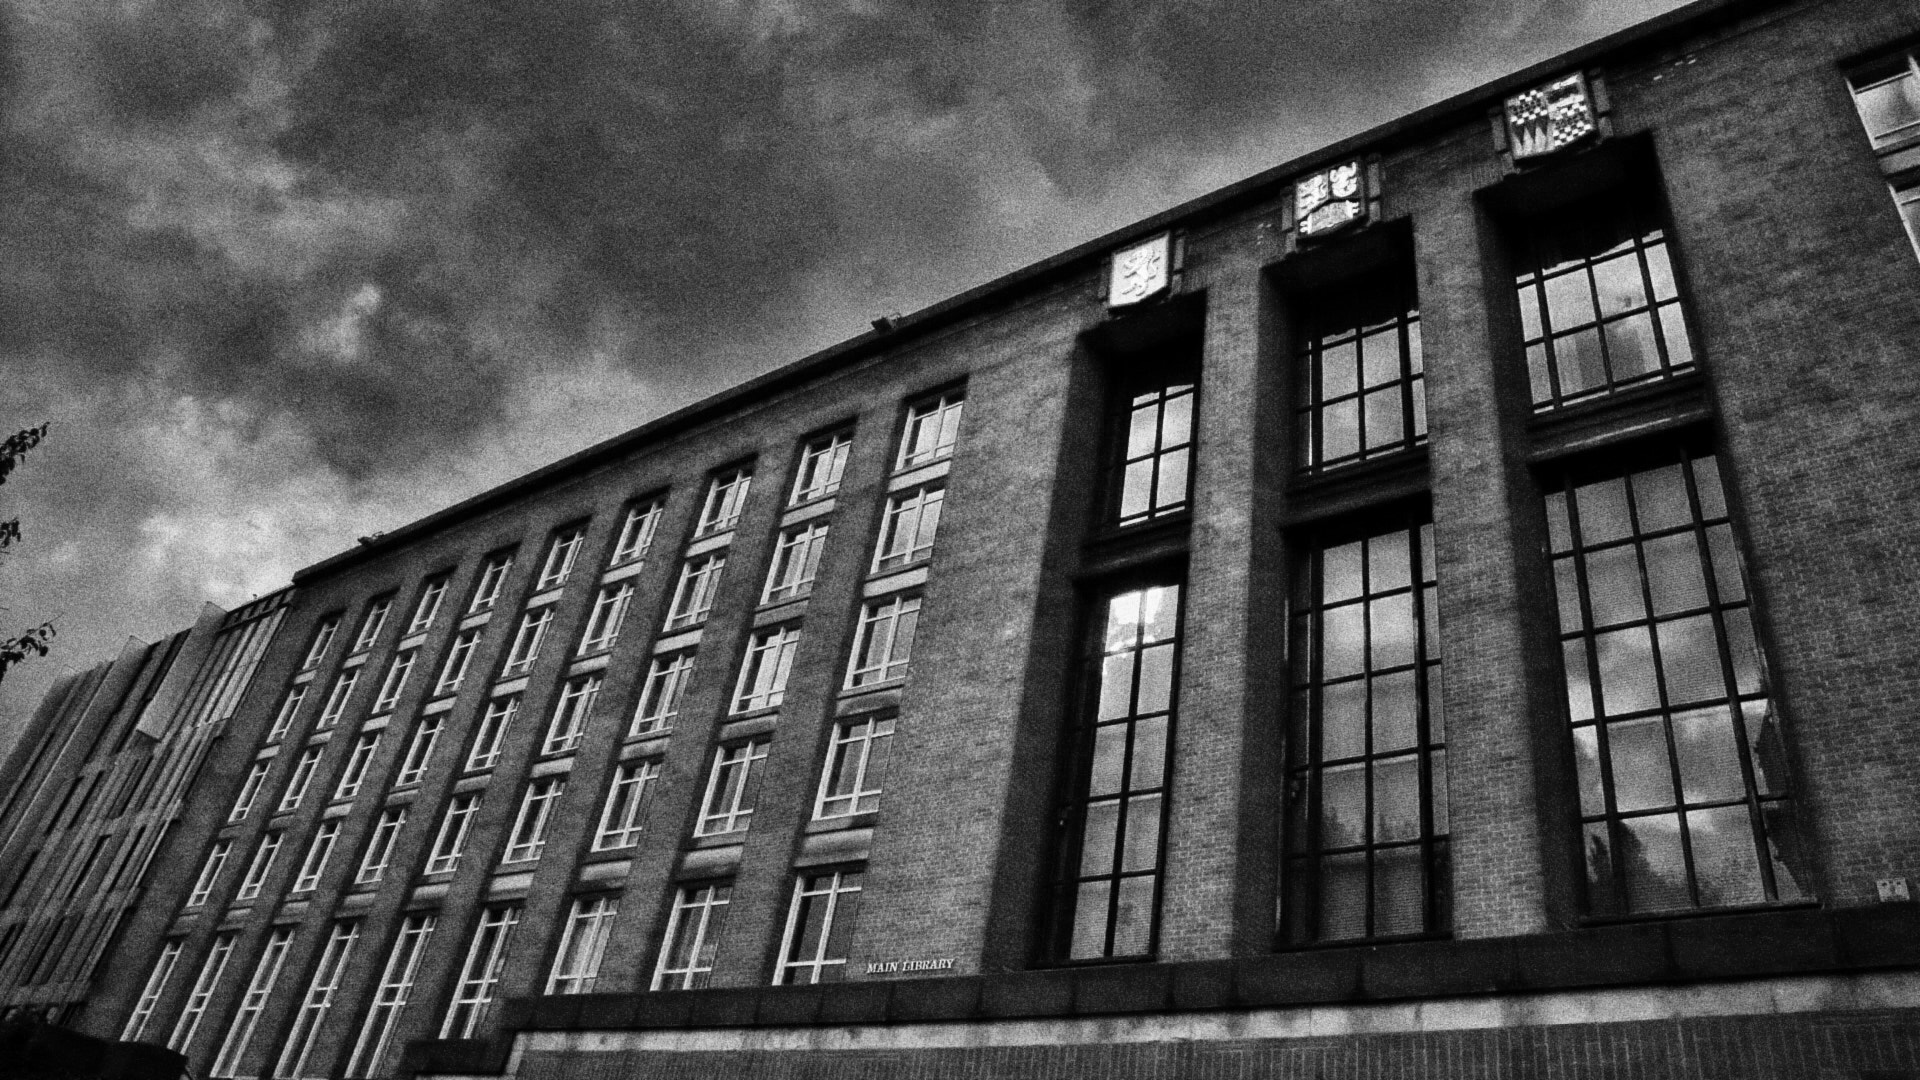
[1294,273,1427,471]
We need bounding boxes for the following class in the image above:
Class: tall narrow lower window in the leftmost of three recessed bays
[1054,584,1183,961]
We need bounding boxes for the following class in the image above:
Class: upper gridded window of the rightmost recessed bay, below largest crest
[1515,198,1693,411]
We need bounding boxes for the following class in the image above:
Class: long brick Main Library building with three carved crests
[0,0,1920,1078]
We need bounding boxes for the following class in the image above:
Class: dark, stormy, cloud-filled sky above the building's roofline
[0,0,1678,744]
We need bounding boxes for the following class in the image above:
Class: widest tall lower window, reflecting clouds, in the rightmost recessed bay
[1548,452,1811,915]
